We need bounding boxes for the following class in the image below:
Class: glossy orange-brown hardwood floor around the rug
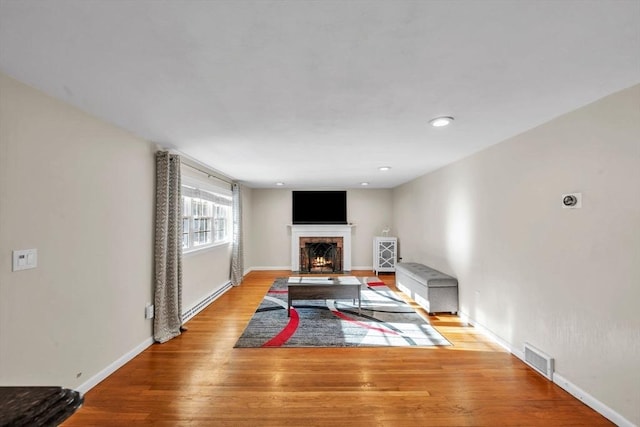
[63,271,613,426]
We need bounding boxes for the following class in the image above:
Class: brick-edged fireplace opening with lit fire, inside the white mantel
[299,237,343,273]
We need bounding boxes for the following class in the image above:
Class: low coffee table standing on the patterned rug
[287,276,362,316]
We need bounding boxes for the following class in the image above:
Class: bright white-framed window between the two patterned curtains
[182,185,231,252]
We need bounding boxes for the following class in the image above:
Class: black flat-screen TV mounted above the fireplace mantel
[292,191,347,224]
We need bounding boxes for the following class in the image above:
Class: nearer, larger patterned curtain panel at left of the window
[153,151,182,343]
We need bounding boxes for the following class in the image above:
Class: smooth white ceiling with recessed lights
[0,0,640,188]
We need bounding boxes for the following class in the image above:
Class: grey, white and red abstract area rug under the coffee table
[235,276,451,348]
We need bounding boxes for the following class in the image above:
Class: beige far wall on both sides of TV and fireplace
[248,189,393,269]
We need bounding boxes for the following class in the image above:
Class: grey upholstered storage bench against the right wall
[396,262,458,314]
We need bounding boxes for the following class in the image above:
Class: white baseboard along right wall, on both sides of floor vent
[458,312,637,427]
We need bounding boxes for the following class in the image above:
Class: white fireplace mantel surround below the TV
[289,224,354,271]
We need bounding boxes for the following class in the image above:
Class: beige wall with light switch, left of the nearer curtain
[0,74,155,388]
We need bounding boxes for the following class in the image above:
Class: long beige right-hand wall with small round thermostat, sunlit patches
[393,86,640,425]
